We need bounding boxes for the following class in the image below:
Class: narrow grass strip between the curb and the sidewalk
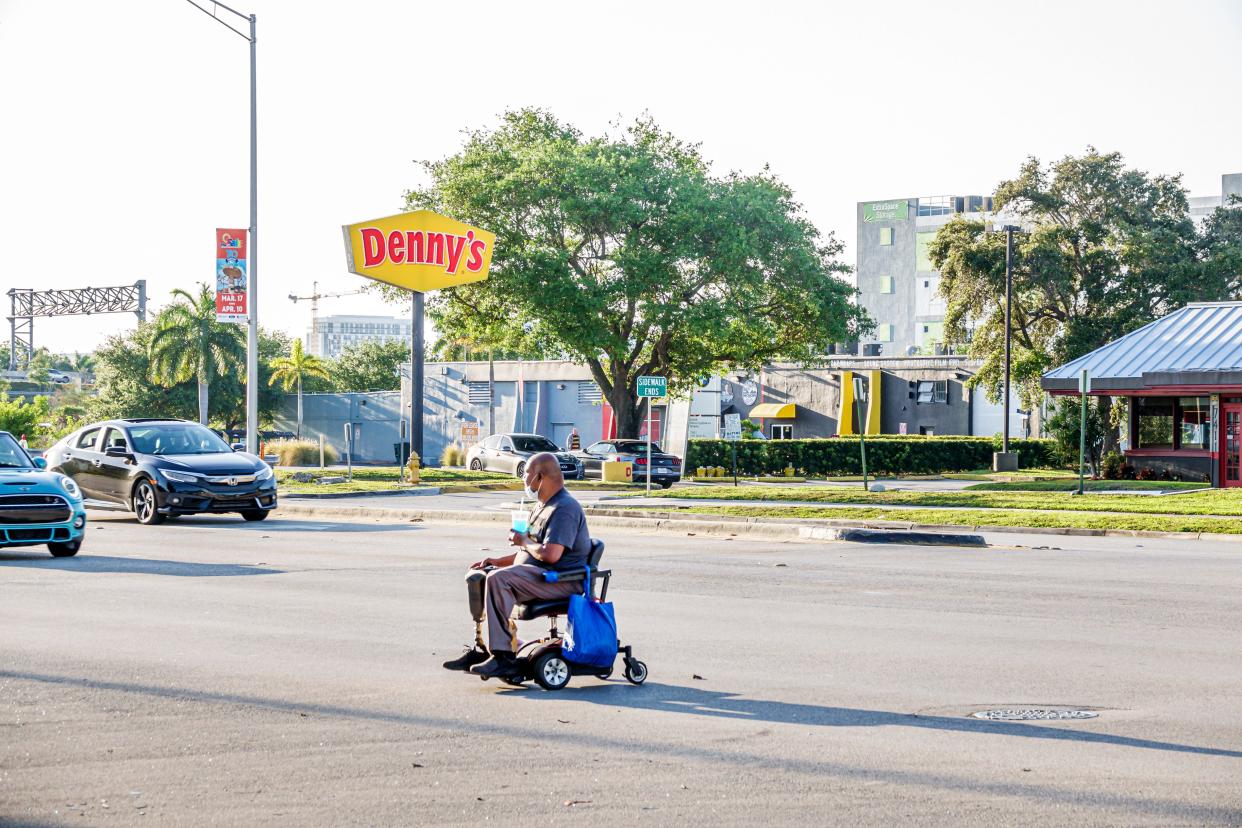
[609,504,1242,535]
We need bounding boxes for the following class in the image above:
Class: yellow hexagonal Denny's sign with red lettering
[344,210,496,293]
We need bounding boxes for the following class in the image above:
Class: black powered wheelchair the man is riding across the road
[466,538,647,690]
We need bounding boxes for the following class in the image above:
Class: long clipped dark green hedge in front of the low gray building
[686,434,1057,475]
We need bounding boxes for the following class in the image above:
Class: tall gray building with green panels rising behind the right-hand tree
[856,195,992,356]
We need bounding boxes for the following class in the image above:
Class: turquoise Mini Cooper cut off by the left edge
[0,431,86,557]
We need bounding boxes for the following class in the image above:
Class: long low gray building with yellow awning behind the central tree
[276,355,1041,466]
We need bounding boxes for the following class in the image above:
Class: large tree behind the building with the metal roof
[928,148,1238,421]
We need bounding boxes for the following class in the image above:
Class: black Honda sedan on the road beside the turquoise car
[43,420,276,524]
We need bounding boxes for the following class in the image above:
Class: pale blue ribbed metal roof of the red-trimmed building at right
[1041,302,1242,392]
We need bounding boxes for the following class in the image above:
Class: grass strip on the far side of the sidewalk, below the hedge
[652,487,1242,518]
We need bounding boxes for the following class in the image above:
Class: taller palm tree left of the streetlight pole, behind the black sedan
[149,283,246,426]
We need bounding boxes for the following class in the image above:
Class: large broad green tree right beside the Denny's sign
[385,109,866,436]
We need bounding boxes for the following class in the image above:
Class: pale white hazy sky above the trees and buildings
[0,0,1242,351]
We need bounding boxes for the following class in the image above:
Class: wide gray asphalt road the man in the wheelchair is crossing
[0,515,1242,826]
